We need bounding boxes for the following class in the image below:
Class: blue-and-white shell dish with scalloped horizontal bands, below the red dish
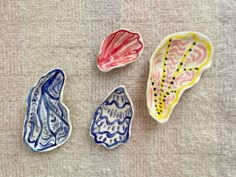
[90,85,134,149]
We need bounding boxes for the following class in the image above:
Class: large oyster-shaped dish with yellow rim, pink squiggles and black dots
[146,32,213,123]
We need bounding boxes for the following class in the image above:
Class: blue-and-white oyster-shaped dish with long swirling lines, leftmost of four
[23,69,72,152]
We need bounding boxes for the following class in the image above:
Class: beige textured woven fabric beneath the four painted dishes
[0,0,236,177]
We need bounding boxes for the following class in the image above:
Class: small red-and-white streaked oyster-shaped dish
[97,29,144,72]
